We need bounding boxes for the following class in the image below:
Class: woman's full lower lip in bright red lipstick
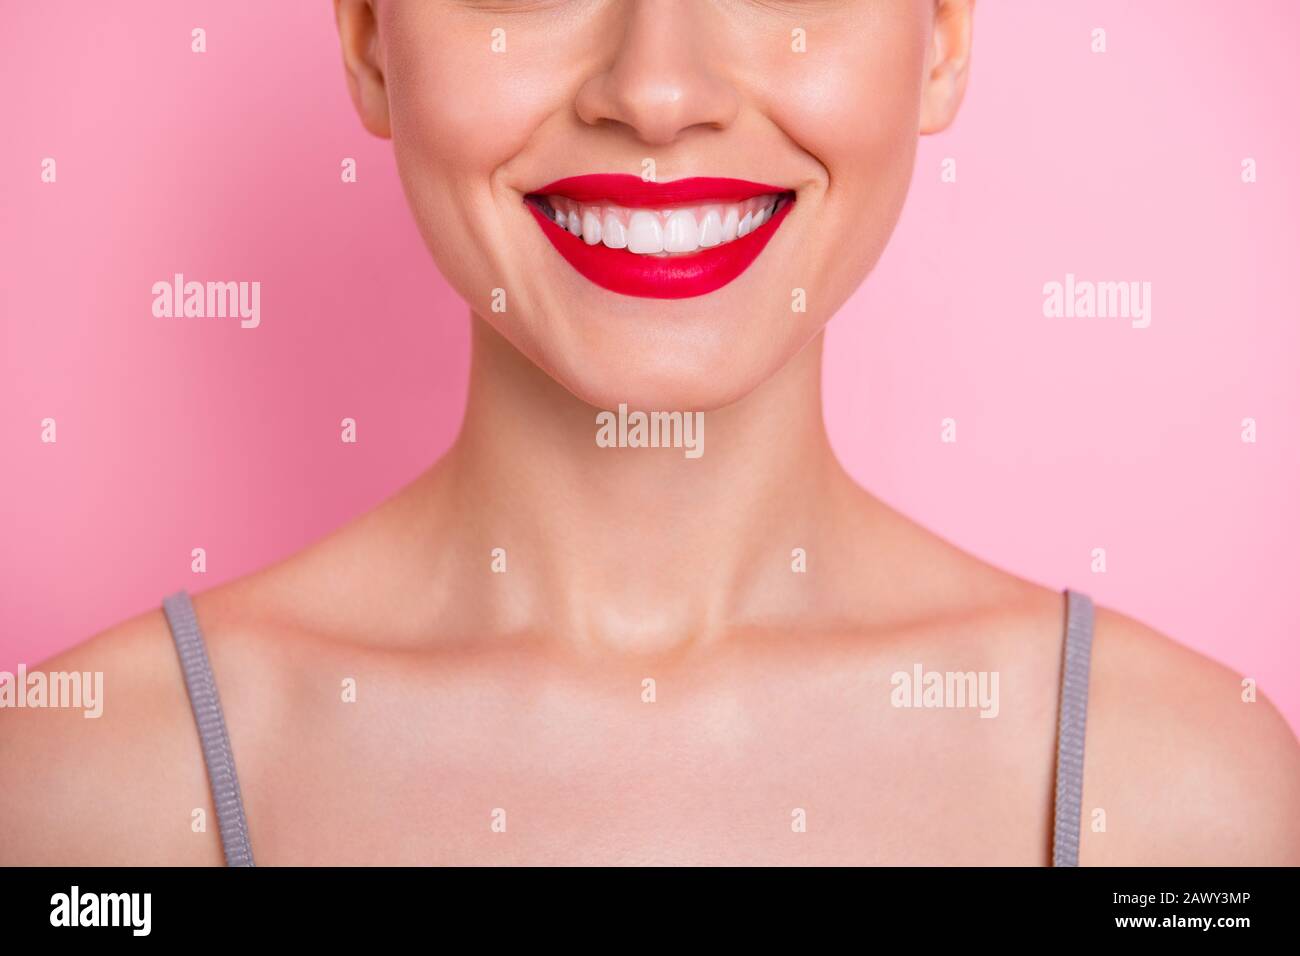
[525,198,794,299]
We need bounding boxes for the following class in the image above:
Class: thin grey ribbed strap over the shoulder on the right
[1052,591,1092,866]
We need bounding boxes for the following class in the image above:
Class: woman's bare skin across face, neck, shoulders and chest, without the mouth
[0,0,1300,865]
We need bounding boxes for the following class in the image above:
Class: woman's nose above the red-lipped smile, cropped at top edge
[576,0,740,146]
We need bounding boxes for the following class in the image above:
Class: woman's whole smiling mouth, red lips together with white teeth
[524,174,794,299]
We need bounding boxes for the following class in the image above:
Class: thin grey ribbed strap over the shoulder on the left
[163,591,254,866]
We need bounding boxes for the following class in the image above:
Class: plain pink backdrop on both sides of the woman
[0,0,1300,726]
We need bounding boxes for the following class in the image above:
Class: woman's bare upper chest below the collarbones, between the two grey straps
[246,650,1050,865]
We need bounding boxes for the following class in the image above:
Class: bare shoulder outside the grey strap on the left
[0,609,221,865]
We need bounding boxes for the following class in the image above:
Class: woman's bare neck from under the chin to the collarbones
[432,316,849,650]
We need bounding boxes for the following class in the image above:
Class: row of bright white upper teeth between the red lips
[541,194,788,255]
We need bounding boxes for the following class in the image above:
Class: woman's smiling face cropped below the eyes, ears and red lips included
[338,0,970,411]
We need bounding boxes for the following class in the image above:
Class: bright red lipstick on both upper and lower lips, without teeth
[525,173,794,299]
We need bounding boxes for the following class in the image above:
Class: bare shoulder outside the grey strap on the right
[1080,609,1300,865]
